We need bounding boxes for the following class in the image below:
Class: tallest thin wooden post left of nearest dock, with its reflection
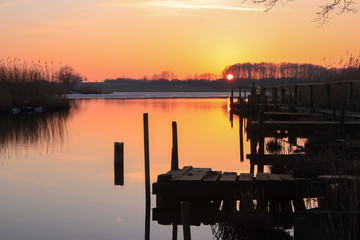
[143,113,150,240]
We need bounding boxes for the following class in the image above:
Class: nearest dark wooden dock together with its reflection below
[153,166,316,225]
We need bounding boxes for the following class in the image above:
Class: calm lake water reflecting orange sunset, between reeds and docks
[0,98,250,240]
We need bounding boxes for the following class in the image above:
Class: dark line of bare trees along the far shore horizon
[104,59,360,85]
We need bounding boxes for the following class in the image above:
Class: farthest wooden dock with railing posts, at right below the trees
[230,80,360,124]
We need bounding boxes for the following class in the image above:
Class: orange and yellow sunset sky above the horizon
[0,0,360,81]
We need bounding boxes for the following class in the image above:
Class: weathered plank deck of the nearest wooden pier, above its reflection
[153,166,310,200]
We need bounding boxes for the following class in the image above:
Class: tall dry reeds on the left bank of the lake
[0,58,69,112]
